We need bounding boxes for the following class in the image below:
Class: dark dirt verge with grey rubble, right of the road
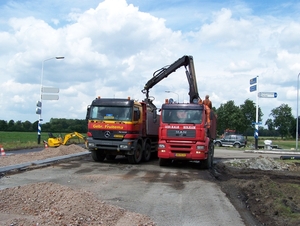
[213,154,300,226]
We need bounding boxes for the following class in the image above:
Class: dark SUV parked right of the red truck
[214,134,247,148]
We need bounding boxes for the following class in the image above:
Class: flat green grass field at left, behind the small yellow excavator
[0,131,86,151]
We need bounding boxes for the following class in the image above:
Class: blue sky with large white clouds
[0,0,300,124]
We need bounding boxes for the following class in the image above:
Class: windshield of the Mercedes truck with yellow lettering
[90,106,132,121]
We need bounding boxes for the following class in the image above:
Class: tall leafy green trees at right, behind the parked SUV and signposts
[214,99,297,138]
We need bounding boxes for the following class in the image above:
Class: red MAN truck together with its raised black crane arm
[142,56,217,169]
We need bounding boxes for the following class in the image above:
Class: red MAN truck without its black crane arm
[158,103,216,168]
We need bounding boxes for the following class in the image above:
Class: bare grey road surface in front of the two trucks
[0,149,245,226]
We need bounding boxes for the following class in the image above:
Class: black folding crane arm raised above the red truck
[142,55,200,108]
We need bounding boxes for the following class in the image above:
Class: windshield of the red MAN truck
[162,109,202,124]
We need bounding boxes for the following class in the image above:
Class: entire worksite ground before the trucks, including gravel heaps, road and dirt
[0,146,300,226]
